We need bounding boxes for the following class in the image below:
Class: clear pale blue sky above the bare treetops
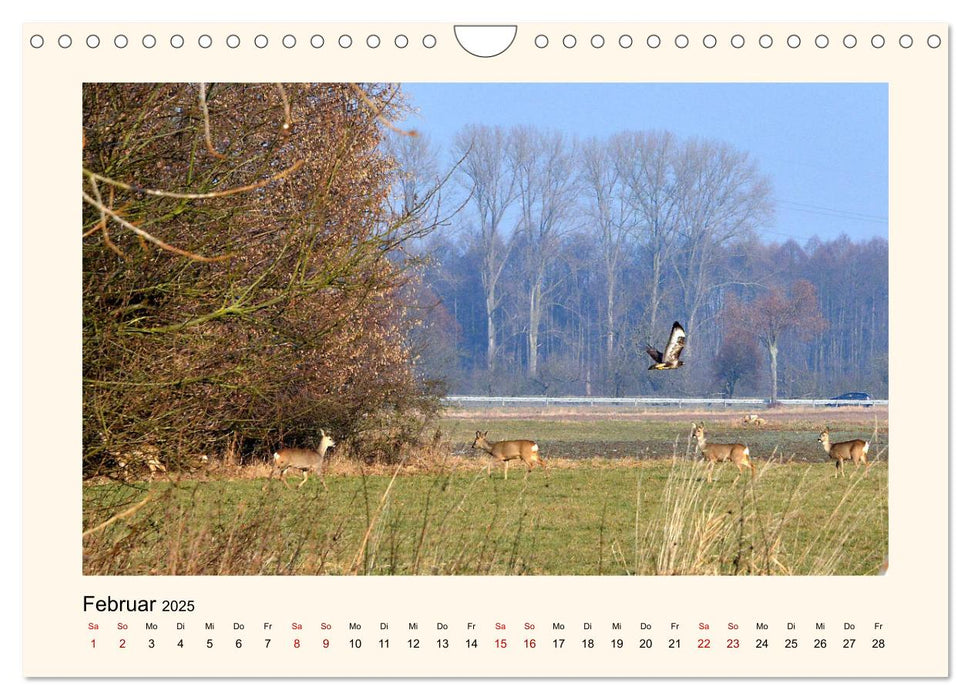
[404,83,888,242]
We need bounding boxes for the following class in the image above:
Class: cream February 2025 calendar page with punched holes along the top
[22,22,950,678]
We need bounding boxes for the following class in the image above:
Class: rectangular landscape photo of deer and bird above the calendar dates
[80,83,890,576]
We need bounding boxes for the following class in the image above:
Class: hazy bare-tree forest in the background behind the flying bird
[390,125,889,398]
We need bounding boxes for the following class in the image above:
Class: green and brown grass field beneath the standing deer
[83,408,889,575]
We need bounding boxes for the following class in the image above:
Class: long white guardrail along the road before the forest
[445,396,888,408]
